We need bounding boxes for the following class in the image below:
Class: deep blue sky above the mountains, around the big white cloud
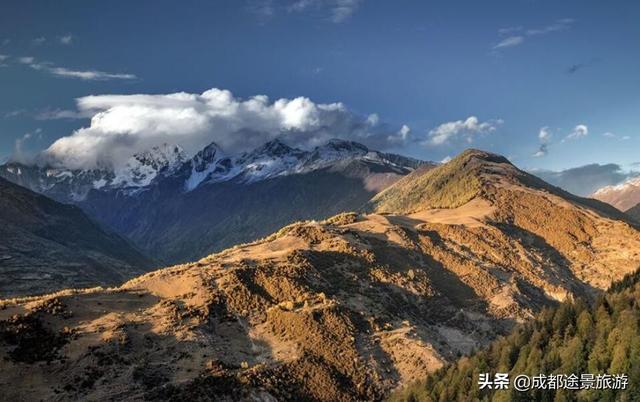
[0,0,640,176]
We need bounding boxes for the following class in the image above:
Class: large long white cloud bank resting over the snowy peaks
[41,88,408,169]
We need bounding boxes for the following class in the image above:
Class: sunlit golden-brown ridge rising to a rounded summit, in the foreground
[0,151,640,401]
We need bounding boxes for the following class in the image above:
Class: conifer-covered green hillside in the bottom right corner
[391,271,640,401]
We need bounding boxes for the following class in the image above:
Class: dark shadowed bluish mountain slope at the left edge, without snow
[0,179,154,297]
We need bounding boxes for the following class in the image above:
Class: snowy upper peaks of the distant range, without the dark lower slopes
[0,139,420,203]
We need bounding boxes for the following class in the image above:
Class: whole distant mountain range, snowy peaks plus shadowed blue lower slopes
[0,140,435,263]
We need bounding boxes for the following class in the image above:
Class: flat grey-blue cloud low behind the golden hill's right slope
[531,163,637,196]
